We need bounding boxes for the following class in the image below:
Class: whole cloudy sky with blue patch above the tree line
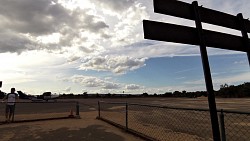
[0,0,250,94]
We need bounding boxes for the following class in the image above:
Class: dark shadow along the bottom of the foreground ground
[0,125,125,141]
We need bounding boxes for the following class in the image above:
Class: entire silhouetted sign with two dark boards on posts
[143,0,250,141]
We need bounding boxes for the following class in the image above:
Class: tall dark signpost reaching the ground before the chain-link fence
[192,1,220,141]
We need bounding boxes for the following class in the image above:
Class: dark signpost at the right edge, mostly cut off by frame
[237,13,250,66]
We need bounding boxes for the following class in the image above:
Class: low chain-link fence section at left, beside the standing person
[0,101,79,124]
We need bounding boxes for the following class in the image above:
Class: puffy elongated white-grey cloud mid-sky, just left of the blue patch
[79,56,146,74]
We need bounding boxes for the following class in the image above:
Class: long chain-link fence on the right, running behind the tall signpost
[98,102,250,141]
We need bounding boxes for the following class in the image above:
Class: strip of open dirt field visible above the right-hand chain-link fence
[80,97,250,112]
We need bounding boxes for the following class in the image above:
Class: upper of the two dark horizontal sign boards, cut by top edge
[154,0,250,32]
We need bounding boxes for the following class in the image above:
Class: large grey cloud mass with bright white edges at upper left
[0,0,110,53]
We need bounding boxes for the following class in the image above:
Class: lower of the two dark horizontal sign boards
[143,20,250,52]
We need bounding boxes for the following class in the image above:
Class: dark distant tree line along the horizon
[0,82,250,99]
